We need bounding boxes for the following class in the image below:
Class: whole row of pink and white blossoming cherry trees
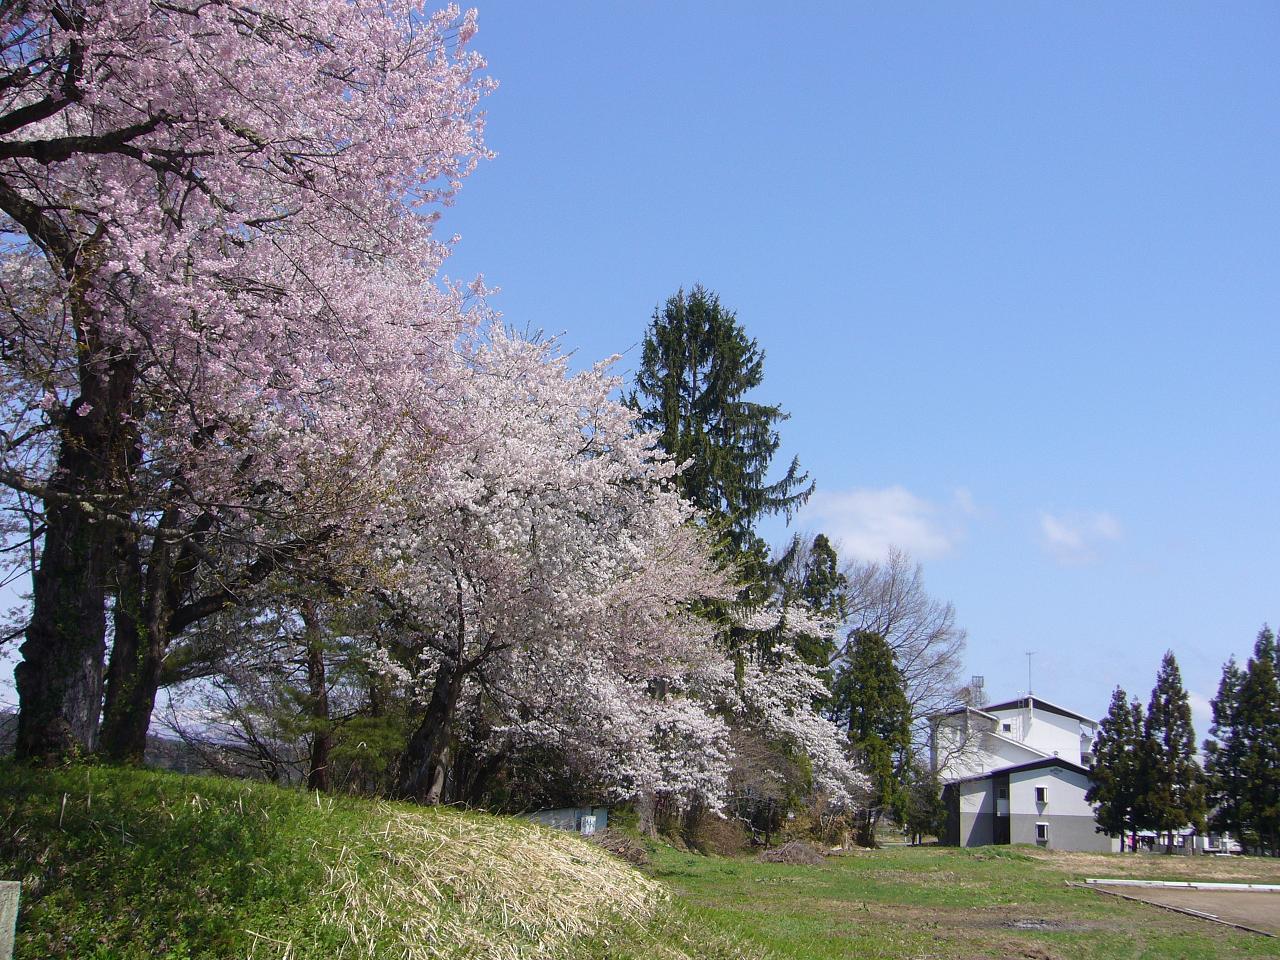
[0,0,861,805]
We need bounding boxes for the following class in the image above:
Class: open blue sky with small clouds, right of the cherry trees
[432,3,1280,736]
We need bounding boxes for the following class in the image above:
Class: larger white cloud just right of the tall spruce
[800,486,972,561]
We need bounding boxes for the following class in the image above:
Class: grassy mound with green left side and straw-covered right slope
[0,763,739,960]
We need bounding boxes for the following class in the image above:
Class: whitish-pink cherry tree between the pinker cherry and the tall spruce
[363,328,727,803]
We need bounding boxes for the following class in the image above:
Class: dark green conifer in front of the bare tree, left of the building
[833,632,911,846]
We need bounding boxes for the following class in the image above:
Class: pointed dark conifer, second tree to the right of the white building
[1140,650,1206,852]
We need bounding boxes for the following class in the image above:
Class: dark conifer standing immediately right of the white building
[1084,687,1143,846]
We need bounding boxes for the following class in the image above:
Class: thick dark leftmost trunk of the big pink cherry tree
[14,344,134,763]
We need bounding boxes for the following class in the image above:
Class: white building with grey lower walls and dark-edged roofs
[931,696,1120,851]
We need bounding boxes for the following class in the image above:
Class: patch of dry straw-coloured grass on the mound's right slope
[318,808,667,960]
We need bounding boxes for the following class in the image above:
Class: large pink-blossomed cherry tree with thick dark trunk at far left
[0,0,489,758]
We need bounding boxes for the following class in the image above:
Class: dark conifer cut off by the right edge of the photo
[1238,627,1280,855]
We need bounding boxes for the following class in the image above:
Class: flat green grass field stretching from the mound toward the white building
[654,847,1280,960]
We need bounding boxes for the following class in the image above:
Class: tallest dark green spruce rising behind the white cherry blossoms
[631,285,813,568]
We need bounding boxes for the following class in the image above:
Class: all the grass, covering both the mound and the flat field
[0,762,1280,960]
